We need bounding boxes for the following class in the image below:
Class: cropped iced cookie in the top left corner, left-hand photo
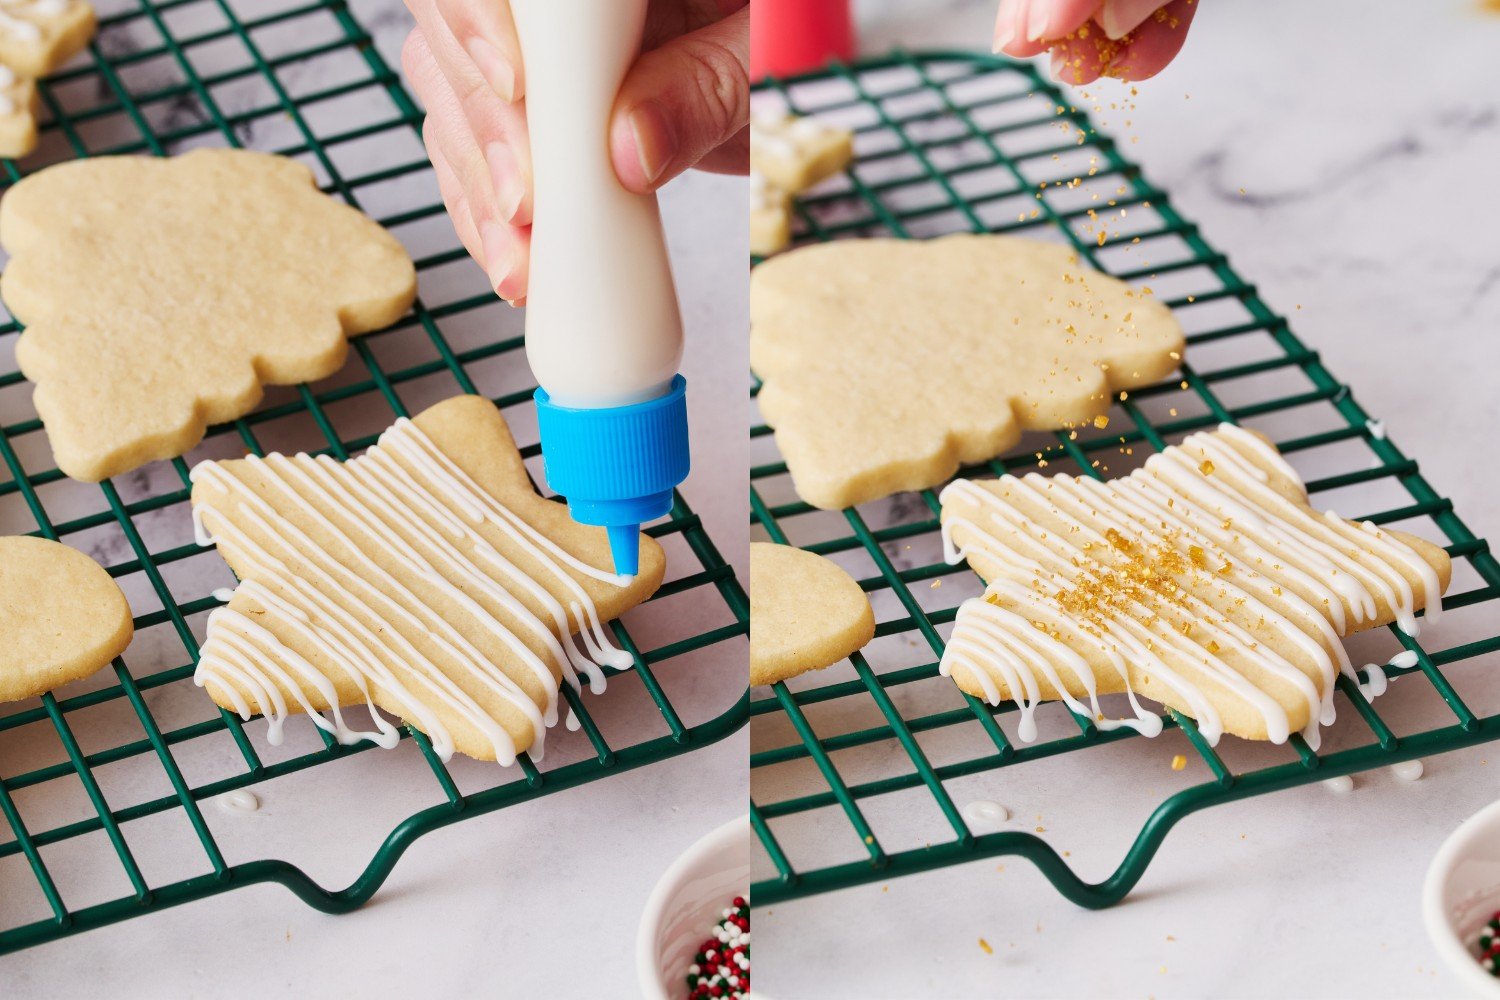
[0,0,98,159]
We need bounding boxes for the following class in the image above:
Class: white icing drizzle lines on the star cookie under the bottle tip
[192,418,632,765]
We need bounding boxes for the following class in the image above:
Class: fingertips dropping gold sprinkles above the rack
[995,0,1197,84]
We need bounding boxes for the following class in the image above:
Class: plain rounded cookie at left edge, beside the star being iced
[0,535,135,702]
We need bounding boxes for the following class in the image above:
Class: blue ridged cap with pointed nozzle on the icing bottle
[536,375,692,576]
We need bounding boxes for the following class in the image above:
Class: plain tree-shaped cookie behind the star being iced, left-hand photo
[0,150,416,481]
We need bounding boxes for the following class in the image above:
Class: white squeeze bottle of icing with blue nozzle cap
[510,0,689,576]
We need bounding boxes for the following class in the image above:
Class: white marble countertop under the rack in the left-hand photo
[0,0,747,997]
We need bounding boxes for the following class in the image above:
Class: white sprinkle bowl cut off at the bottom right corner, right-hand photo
[1422,802,1500,997]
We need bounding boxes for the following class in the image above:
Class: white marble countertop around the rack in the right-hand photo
[756,0,1500,999]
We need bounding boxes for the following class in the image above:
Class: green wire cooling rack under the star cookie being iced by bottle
[0,0,749,954]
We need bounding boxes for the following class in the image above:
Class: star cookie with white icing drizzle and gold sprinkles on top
[941,424,1452,748]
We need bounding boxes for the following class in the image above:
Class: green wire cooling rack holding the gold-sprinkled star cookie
[750,52,1500,907]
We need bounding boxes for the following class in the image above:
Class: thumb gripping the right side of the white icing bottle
[609,6,750,193]
